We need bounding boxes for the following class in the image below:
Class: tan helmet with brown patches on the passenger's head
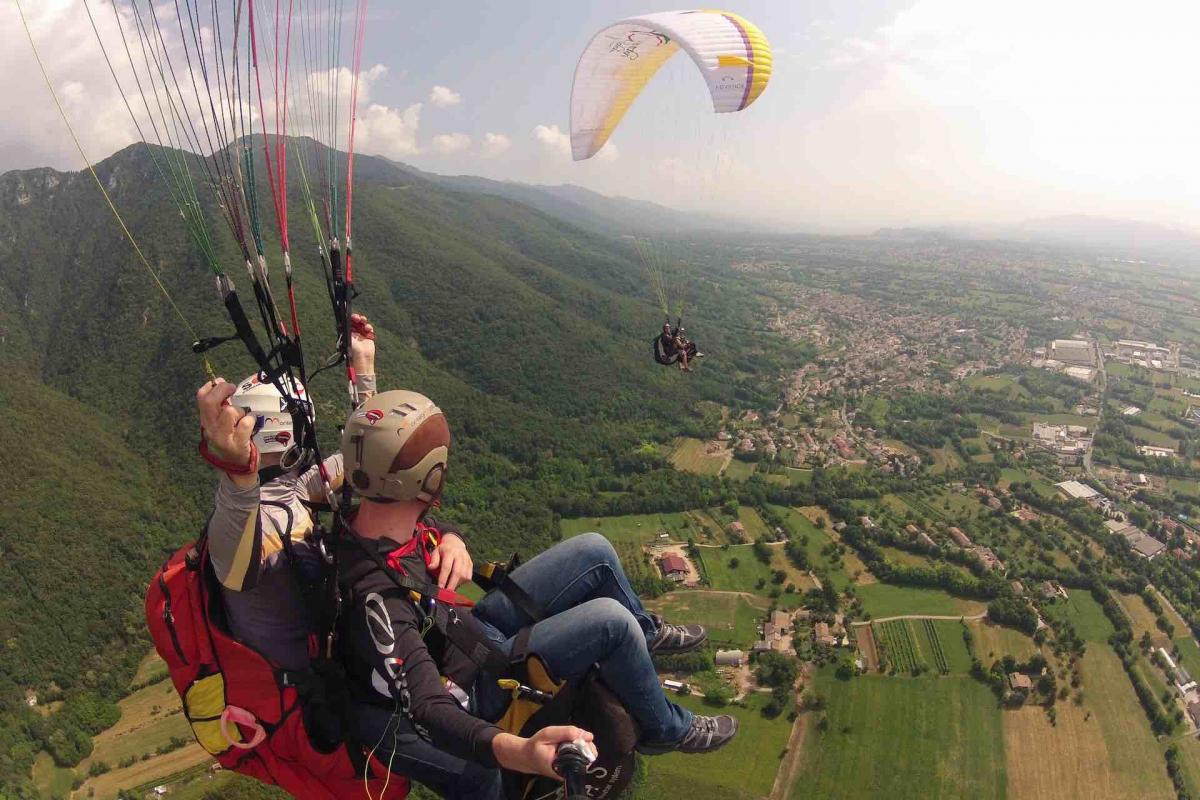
[342,390,450,504]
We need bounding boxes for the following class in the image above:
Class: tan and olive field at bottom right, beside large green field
[1003,646,1175,800]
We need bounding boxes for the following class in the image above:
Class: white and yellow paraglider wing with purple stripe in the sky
[571,10,772,161]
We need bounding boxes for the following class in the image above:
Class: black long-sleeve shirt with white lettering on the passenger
[342,525,500,766]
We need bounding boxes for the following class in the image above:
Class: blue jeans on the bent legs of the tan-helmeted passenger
[475,534,692,744]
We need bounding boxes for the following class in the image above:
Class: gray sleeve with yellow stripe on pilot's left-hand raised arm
[208,474,263,591]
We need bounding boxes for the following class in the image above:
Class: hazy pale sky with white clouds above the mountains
[0,0,1200,231]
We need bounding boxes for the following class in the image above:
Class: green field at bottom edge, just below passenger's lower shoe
[637,696,808,800]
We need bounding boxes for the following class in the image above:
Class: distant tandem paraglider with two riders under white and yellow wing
[571,10,772,371]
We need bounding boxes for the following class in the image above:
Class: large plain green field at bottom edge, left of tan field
[788,674,1006,800]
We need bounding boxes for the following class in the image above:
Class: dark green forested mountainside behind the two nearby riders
[0,145,793,795]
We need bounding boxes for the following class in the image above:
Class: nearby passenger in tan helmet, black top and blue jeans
[341,391,737,800]
